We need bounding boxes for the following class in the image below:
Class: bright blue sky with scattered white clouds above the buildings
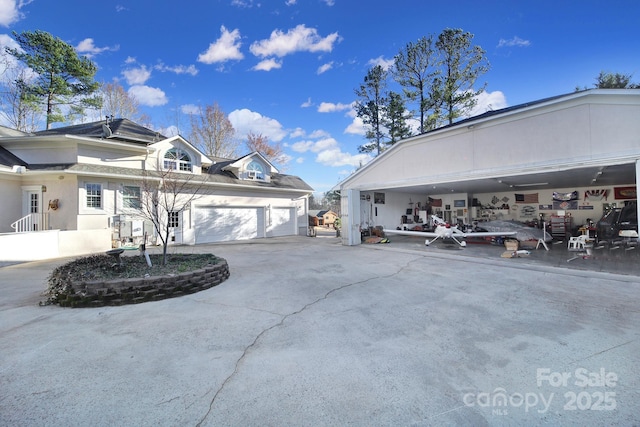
[0,0,640,197]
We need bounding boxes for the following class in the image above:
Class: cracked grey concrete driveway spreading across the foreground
[0,236,640,426]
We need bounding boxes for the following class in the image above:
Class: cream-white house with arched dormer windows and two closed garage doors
[0,119,313,261]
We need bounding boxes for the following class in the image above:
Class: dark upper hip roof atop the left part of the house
[35,119,167,145]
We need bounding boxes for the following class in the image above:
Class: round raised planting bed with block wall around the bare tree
[41,254,230,307]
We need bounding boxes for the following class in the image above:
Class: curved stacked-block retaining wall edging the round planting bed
[58,258,230,308]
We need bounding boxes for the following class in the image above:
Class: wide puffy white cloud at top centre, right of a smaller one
[249,24,340,58]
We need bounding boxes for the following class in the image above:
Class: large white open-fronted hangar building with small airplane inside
[339,89,640,245]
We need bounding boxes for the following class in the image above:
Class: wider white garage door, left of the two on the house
[194,206,264,243]
